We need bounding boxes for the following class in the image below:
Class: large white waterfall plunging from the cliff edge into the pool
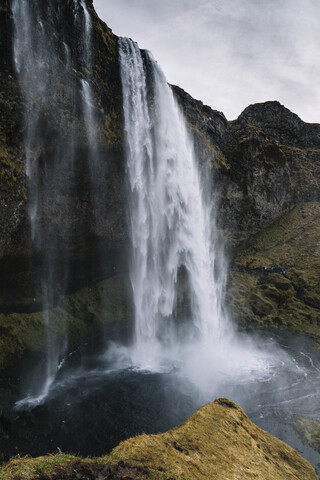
[119,38,228,368]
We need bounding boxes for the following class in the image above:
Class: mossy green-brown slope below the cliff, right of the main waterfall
[229,202,320,339]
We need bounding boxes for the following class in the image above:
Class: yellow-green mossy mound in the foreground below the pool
[0,398,317,480]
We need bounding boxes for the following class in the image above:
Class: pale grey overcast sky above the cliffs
[94,0,320,123]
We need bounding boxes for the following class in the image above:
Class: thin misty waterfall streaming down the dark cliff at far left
[12,0,97,397]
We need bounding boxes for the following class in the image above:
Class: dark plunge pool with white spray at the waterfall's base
[0,333,320,474]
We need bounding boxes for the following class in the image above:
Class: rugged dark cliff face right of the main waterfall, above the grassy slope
[174,87,320,241]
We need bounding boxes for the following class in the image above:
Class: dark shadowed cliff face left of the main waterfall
[0,0,125,311]
